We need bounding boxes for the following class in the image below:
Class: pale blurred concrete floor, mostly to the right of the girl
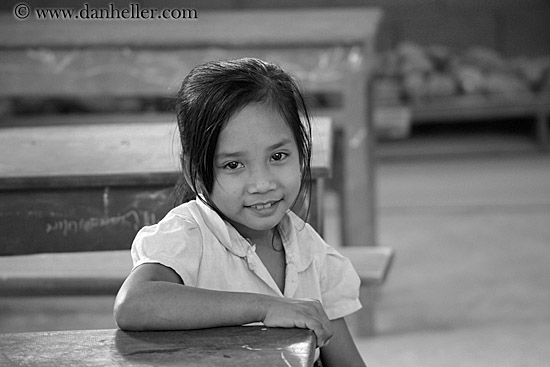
[0,148,550,367]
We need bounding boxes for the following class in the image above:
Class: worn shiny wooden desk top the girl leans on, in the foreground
[0,326,315,367]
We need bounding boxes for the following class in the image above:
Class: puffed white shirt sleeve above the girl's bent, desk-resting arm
[131,213,203,286]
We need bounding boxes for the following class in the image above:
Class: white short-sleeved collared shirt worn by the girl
[131,199,361,319]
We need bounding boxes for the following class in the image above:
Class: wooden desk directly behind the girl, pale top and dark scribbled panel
[0,116,333,255]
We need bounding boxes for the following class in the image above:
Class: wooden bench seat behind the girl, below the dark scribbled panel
[0,246,394,336]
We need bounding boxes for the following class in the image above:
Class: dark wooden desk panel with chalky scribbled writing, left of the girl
[0,180,175,255]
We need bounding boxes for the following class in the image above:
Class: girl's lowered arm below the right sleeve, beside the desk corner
[321,318,366,367]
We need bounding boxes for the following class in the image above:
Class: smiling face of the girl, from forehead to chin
[210,104,301,242]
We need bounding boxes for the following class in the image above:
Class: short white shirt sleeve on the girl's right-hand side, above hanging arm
[321,246,361,320]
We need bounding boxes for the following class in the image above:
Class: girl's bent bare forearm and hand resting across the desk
[114,264,332,346]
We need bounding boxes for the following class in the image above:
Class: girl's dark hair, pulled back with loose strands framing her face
[176,58,311,214]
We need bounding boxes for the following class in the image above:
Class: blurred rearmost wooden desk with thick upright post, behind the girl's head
[0,8,382,249]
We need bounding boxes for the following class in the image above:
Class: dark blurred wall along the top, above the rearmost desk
[0,0,550,56]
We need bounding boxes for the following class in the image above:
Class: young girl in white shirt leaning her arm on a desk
[114,59,364,367]
